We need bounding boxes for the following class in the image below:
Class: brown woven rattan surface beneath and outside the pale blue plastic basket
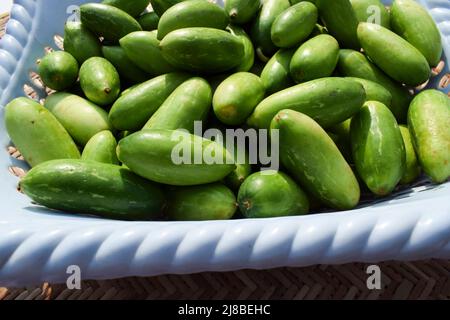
[0,14,450,300]
